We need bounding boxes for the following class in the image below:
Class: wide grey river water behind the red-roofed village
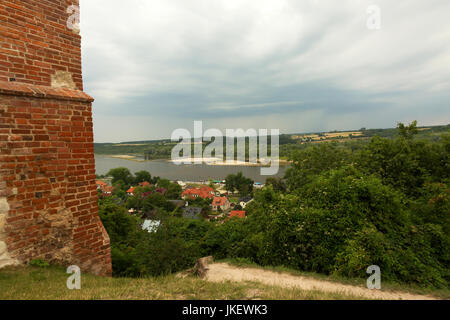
[95,154,287,183]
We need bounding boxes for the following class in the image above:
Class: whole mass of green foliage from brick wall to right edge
[100,123,450,287]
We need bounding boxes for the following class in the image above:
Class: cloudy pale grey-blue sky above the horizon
[80,0,450,142]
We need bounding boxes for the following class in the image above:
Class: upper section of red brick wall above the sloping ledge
[0,0,83,90]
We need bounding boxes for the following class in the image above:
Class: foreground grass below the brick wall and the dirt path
[0,266,370,300]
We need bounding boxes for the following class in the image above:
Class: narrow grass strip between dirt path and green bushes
[221,259,450,300]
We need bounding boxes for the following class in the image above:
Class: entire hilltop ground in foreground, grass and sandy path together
[0,263,449,300]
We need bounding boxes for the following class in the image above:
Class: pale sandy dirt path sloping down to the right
[205,263,434,300]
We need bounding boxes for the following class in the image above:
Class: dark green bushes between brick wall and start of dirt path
[99,198,214,277]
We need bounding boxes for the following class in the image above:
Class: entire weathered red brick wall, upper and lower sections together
[0,0,111,275]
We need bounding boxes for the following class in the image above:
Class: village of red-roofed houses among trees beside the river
[96,174,264,232]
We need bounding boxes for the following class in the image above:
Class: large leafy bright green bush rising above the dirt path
[237,166,449,287]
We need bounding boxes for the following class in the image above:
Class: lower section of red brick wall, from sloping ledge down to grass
[0,82,111,275]
